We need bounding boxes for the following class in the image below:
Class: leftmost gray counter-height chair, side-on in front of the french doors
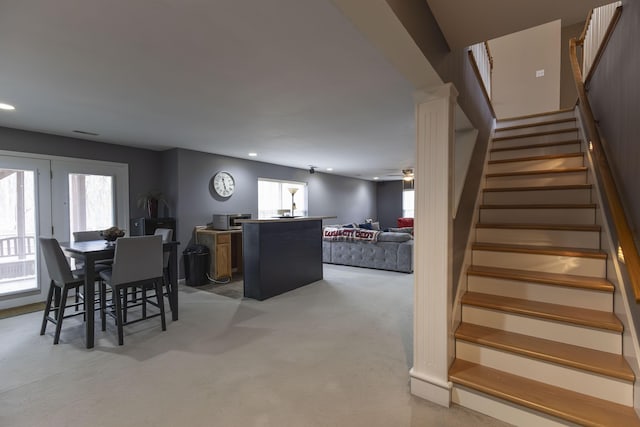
[39,237,85,344]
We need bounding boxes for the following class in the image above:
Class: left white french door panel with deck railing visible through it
[0,155,51,309]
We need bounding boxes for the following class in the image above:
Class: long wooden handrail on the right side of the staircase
[570,8,640,303]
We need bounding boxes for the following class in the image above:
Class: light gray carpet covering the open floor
[0,265,510,427]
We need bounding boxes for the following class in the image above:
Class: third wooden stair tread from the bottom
[462,292,623,333]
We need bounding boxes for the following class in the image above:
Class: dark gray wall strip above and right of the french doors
[0,127,163,218]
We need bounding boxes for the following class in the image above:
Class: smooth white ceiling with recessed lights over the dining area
[0,0,601,179]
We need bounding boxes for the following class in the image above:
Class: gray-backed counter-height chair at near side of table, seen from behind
[100,236,167,345]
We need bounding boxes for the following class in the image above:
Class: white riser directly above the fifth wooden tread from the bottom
[476,228,600,249]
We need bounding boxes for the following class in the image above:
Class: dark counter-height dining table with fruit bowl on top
[60,240,180,348]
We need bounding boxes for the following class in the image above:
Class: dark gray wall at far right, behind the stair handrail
[588,0,640,241]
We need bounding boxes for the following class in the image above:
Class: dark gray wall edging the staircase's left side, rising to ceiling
[387,0,494,292]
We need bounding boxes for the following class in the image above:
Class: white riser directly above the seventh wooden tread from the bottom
[482,188,591,205]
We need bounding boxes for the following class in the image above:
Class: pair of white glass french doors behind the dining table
[0,152,129,309]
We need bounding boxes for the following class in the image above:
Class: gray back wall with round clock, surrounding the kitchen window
[163,149,376,276]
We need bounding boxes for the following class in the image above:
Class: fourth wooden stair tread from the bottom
[467,265,614,292]
